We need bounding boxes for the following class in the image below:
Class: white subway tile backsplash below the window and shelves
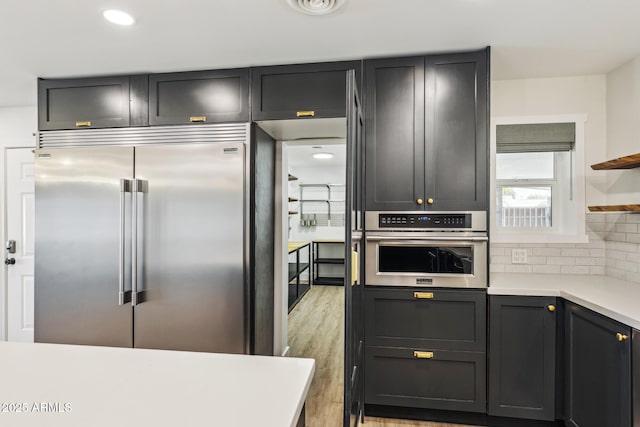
[490,213,640,282]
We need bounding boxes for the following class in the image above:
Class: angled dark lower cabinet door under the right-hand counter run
[565,303,631,427]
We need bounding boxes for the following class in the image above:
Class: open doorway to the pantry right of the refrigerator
[260,119,347,426]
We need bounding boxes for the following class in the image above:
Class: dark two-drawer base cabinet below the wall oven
[364,287,486,412]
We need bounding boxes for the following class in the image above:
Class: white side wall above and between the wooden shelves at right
[600,56,640,205]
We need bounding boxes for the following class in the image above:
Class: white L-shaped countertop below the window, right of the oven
[487,273,640,329]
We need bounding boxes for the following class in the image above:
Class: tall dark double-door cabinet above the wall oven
[365,49,489,211]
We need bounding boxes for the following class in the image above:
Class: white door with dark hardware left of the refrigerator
[4,148,34,342]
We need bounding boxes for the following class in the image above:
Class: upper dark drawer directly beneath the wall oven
[365,287,487,352]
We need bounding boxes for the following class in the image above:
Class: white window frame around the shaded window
[489,114,589,243]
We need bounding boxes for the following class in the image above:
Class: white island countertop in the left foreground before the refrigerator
[0,342,315,427]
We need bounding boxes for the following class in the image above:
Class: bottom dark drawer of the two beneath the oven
[365,347,486,412]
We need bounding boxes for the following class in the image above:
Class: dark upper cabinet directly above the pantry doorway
[251,61,362,121]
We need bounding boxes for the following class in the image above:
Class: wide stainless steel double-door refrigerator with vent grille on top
[35,124,249,353]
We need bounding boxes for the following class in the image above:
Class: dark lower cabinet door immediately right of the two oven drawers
[488,296,559,421]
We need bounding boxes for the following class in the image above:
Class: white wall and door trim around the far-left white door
[0,106,38,340]
